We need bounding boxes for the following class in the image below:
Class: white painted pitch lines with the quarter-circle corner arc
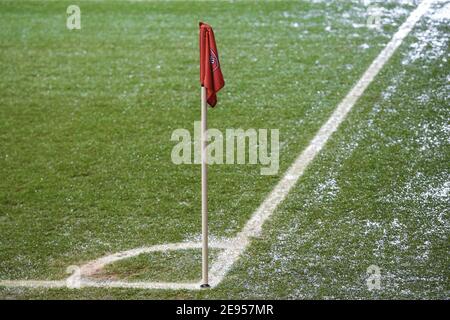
[0,0,437,290]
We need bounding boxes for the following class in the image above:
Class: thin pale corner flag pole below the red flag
[201,86,209,288]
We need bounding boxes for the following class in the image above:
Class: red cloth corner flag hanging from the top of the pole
[200,22,225,107]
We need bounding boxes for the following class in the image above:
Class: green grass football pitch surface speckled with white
[0,0,450,299]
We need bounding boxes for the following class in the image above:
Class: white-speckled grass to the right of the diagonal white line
[234,3,450,298]
